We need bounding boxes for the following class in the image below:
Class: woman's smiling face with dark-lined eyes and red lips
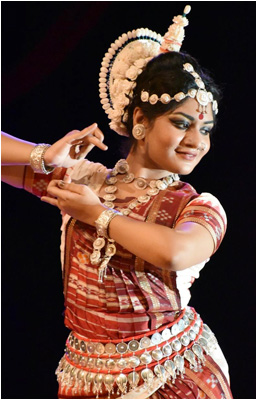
[137,98,214,175]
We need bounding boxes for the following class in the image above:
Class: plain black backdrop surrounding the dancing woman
[1,1,255,399]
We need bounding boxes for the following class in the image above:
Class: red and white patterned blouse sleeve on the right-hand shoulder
[176,193,227,253]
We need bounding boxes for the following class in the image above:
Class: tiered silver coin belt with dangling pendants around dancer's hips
[56,307,217,398]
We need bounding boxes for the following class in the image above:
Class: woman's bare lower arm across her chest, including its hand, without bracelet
[42,181,218,271]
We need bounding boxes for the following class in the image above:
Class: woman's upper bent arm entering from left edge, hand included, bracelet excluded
[1,124,107,188]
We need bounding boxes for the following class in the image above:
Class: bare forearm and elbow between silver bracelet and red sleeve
[109,216,214,271]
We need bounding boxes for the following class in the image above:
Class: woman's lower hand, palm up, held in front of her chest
[41,180,105,225]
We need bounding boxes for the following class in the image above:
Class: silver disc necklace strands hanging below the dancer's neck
[103,159,179,215]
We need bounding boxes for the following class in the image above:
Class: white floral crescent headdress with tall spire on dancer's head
[99,6,216,136]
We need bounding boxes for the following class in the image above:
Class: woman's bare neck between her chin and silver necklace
[126,151,171,179]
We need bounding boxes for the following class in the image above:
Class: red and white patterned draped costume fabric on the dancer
[25,160,232,399]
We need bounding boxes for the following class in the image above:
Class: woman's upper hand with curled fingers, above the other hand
[44,123,107,168]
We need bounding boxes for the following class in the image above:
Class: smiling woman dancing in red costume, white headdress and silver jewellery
[1,6,232,399]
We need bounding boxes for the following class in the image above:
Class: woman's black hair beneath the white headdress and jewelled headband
[123,52,221,144]
